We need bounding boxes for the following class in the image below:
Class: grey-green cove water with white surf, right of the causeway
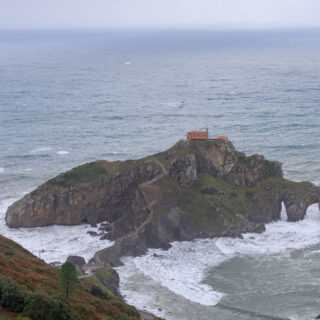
[118,205,320,320]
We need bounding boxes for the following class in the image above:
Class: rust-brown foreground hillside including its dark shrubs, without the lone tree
[0,236,157,320]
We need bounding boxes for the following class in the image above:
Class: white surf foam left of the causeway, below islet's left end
[0,199,113,263]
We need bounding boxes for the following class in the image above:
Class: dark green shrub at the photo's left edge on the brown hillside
[0,278,25,313]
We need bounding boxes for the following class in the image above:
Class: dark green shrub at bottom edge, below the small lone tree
[23,294,72,320]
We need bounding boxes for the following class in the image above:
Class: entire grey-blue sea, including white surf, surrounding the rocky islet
[0,30,320,320]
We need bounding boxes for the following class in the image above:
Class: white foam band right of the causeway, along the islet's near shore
[118,205,320,311]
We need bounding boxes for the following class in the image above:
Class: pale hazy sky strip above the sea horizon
[0,0,320,28]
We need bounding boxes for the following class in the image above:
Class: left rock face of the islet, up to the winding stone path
[6,161,161,231]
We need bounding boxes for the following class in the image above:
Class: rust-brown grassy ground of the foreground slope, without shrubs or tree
[0,236,140,320]
